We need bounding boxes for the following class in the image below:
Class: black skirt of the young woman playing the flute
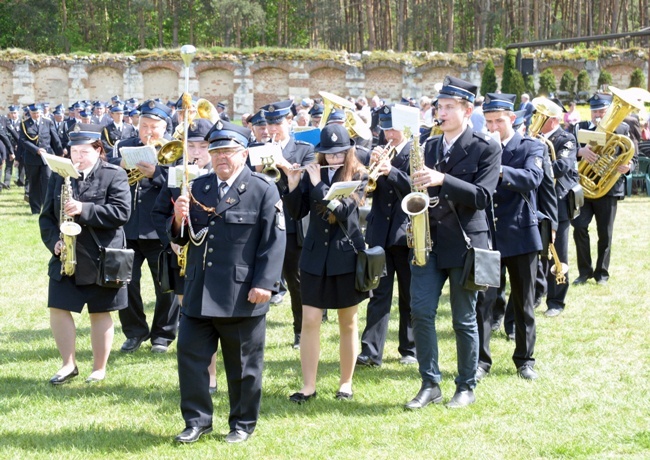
[300,270,368,310]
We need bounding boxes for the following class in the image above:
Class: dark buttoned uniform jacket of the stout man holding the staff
[167,167,286,318]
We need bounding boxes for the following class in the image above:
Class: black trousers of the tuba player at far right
[571,196,618,281]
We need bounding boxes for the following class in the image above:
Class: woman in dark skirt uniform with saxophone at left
[39,127,131,385]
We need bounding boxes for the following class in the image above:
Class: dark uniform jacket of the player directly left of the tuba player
[548,128,578,220]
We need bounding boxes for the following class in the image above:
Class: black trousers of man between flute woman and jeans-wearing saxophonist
[361,246,415,364]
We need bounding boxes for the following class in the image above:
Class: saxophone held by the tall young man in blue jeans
[402,128,430,267]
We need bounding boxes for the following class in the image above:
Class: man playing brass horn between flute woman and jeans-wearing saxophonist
[357,107,417,366]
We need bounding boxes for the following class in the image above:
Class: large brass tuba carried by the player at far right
[578,86,643,199]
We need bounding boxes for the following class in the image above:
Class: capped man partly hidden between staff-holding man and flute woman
[262,99,315,348]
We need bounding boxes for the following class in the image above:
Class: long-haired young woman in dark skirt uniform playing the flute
[284,124,368,403]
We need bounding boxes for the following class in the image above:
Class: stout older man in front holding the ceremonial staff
[168,121,285,443]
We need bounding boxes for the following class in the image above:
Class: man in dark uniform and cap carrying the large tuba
[571,94,638,285]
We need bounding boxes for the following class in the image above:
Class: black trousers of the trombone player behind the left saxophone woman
[119,239,179,345]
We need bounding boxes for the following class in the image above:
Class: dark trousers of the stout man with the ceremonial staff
[177,315,266,433]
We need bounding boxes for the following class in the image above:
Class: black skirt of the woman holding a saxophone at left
[47,276,129,313]
